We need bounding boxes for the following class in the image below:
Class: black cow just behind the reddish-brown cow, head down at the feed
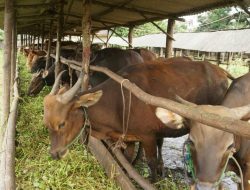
[27,48,143,96]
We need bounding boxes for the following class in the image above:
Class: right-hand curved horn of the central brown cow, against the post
[57,73,83,104]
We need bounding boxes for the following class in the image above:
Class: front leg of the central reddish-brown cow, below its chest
[142,137,157,182]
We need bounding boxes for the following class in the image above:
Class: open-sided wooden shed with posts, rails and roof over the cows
[0,0,250,190]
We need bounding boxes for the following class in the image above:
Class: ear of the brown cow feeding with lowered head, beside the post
[74,90,102,108]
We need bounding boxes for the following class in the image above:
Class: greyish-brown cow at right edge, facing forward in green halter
[157,73,250,190]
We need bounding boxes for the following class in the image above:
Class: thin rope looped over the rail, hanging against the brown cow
[114,79,131,149]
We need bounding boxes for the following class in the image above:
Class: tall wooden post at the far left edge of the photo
[0,0,16,189]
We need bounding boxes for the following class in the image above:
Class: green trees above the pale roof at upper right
[197,7,250,31]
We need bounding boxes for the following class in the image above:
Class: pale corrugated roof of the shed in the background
[133,29,250,53]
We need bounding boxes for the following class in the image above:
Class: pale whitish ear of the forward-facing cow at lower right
[155,107,185,129]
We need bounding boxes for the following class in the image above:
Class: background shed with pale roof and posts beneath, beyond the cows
[109,29,250,62]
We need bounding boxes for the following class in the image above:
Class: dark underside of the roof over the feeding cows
[0,0,247,34]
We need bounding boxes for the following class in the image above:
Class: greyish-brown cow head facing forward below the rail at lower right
[156,101,250,190]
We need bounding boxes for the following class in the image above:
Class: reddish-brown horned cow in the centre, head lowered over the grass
[44,62,232,181]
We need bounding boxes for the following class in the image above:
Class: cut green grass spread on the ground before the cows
[15,56,120,190]
